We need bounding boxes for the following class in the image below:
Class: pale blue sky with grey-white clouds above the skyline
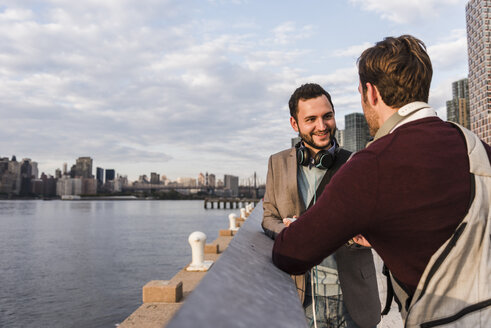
[0,0,468,183]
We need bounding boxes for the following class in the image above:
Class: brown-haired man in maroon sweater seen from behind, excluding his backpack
[273,35,491,302]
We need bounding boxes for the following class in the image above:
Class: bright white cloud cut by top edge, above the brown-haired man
[349,0,462,23]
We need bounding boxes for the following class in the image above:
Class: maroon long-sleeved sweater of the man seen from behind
[273,117,491,293]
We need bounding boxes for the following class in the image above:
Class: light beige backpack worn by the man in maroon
[385,123,491,328]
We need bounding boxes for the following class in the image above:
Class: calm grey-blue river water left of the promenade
[0,201,233,327]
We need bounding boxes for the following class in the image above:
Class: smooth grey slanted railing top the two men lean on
[167,203,307,328]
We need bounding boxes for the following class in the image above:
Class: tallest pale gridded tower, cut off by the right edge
[465,0,491,144]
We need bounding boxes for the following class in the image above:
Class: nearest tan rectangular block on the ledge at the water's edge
[143,280,182,303]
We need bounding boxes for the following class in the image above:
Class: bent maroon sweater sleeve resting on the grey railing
[272,151,378,274]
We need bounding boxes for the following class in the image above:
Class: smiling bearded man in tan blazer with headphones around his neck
[262,83,380,328]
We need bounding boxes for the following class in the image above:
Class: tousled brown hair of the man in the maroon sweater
[358,35,433,108]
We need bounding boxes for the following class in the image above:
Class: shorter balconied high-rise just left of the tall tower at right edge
[447,79,470,129]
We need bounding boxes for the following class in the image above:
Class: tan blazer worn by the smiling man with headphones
[262,148,381,327]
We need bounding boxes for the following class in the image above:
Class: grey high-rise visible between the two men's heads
[344,113,370,152]
